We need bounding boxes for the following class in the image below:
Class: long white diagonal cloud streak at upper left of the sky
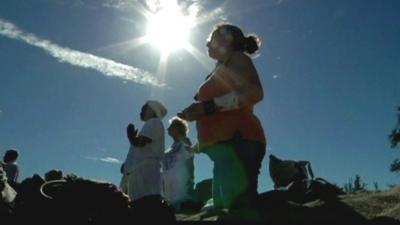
[0,19,162,86]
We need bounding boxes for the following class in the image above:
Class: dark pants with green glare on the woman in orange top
[204,134,265,209]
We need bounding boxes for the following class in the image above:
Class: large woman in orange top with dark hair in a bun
[178,23,266,212]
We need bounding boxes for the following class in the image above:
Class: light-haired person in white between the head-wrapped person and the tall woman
[162,117,194,210]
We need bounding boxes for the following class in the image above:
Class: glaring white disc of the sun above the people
[146,7,193,54]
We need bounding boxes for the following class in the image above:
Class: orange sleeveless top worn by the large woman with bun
[196,65,266,148]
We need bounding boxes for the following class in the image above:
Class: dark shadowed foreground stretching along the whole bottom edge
[0,172,400,225]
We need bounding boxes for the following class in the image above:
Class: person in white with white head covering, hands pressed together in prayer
[123,101,167,201]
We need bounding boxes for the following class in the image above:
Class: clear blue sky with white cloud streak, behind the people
[0,0,400,191]
